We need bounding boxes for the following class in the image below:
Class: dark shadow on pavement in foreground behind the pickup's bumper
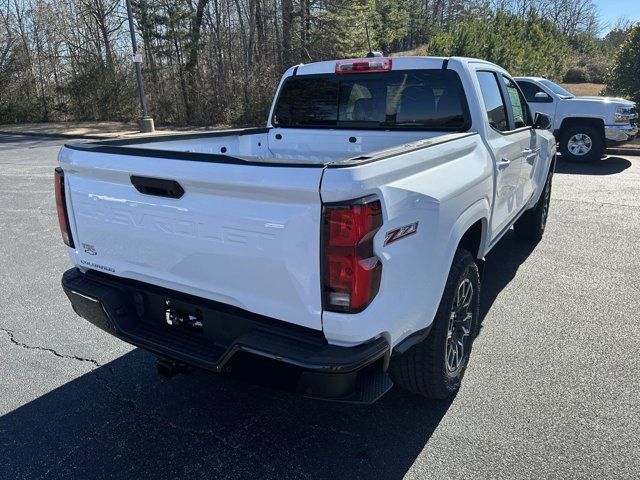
[0,342,451,480]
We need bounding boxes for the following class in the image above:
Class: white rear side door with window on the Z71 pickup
[476,70,527,239]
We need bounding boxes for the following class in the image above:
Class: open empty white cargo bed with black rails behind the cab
[66,128,469,166]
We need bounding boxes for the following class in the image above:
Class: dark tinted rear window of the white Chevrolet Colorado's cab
[272,69,471,131]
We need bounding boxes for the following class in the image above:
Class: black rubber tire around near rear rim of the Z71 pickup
[390,249,480,399]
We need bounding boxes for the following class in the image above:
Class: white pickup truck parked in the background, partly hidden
[515,77,638,162]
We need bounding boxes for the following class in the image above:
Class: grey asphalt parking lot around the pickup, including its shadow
[0,136,640,480]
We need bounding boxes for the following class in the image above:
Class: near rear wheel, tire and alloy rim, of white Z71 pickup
[390,249,480,399]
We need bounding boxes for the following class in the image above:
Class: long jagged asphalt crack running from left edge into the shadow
[0,327,240,450]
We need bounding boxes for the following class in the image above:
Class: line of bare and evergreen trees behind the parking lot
[0,0,630,125]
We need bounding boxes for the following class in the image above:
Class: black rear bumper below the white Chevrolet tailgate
[62,268,393,403]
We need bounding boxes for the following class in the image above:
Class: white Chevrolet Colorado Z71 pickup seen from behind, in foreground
[55,57,556,403]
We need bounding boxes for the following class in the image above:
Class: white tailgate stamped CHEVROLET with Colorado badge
[59,148,322,329]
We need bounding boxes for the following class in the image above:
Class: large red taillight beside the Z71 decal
[323,199,382,313]
